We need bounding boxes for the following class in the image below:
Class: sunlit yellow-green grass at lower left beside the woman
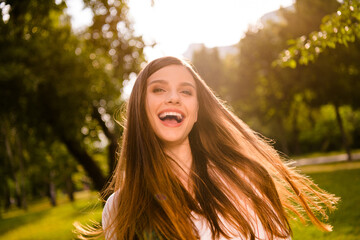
[0,192,102,240]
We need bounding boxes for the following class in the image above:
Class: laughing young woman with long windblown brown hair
[98,57,337,240]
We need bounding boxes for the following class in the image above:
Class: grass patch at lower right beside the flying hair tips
[291,166,360,240]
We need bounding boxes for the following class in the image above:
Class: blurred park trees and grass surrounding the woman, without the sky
[0,0,360,240]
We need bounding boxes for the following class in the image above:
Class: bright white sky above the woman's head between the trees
[66,0,294,61]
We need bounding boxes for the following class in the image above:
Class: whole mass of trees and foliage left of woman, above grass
[0,0,144,208]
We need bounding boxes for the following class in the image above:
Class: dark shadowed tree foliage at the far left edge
[0,1,107,193]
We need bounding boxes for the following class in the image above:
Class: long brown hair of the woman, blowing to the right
[86,57,338,239]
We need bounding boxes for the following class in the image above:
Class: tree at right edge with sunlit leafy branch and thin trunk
[274,1,360,160]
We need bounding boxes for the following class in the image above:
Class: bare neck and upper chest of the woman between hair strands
[165,138,192,190]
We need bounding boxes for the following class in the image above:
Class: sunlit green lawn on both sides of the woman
[0,163,360,240]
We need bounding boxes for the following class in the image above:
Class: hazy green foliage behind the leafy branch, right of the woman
[225,0,360,154]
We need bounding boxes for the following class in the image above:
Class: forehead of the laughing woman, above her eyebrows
[147,65,195,85]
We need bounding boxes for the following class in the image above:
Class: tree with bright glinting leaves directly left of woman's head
[82,0,145,172]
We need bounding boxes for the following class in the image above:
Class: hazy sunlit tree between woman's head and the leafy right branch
[230,0,338,153]
